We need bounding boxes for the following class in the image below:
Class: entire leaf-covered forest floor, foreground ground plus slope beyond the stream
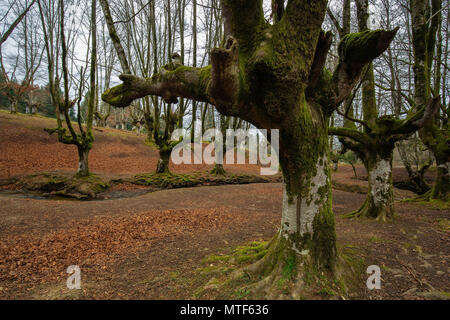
[0,113,450,299]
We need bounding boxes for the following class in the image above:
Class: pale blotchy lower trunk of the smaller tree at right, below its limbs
[346,153,394,222]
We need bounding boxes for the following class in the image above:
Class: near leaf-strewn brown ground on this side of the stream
[0,184,450,299]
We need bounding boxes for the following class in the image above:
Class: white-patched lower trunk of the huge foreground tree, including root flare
[246,150,337,299]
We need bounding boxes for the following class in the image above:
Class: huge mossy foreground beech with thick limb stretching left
[102,0,396,296]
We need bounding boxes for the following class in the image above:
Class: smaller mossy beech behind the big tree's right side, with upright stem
[329,0,440,221]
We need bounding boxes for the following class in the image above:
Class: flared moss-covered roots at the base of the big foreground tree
[218,234,356,300]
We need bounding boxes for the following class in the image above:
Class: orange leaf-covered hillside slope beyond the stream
[0,111,259,179]
